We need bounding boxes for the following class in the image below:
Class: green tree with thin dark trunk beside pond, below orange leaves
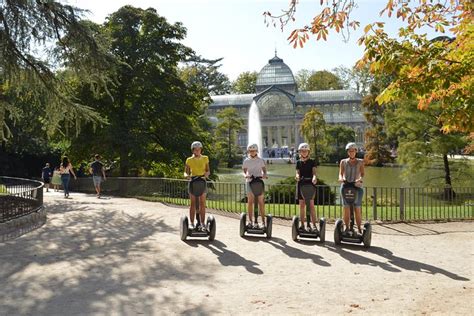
[386,101,473,199]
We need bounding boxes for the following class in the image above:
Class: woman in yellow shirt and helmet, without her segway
[184,141,211,230]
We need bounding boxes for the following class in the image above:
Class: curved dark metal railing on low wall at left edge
[0,176,44,223]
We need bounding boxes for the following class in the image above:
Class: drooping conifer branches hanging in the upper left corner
[0,1,111,140]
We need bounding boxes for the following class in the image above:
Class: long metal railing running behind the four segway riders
[71,177,474,221]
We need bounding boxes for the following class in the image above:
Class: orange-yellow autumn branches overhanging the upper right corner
[264,0,474,133]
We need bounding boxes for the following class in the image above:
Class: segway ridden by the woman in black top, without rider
[291,178,326,242]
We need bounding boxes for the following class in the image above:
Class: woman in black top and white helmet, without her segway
[296,143,317,230]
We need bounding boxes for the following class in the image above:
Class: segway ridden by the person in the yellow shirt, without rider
[180,176,216,241]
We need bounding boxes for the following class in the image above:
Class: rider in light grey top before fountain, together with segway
[240,144,272,238]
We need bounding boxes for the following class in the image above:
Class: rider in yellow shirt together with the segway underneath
[180,141,216,241]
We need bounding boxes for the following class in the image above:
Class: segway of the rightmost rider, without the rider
[334,182,372,248]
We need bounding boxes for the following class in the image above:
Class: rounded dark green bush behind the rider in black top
[265,177,336,205]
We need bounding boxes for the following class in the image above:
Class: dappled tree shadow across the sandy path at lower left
[0,200,210,315]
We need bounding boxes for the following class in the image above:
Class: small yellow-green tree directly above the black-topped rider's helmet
[300,108,327,162]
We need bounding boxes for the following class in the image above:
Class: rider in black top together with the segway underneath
[292,143,326,242]
